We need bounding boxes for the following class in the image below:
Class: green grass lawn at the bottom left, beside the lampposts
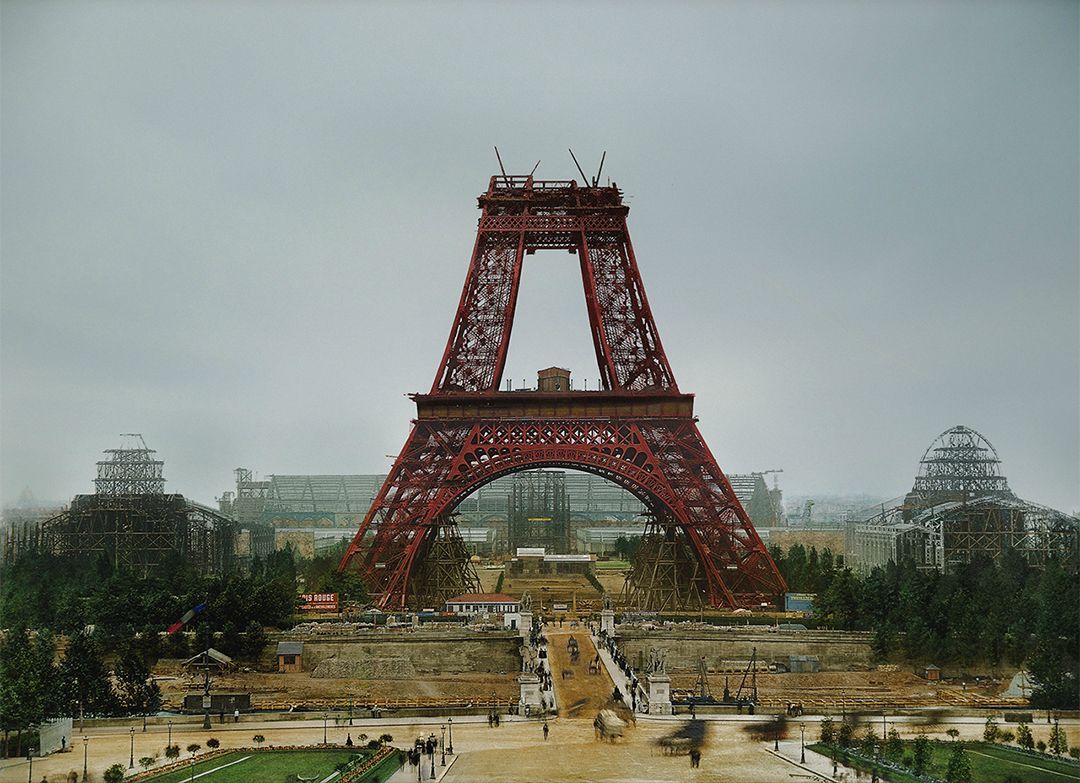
[145,751,371,783]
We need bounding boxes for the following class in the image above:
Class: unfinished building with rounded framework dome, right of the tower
[847,426,1080,571]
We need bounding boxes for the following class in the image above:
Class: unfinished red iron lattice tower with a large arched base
[339,176,785,609]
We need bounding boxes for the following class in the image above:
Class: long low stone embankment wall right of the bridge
[616,625,873,672]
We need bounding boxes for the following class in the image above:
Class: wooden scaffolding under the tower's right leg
[622,516,707,611]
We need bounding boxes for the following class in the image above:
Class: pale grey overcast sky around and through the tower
[0,0,1080,511]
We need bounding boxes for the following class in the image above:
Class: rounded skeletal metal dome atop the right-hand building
[914,424,1011,500]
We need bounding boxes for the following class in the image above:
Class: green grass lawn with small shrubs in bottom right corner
[809,742,1080,783]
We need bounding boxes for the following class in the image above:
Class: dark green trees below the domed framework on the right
[772,544,1080,708]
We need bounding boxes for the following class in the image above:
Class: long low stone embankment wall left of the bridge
[272,630,522,679]
